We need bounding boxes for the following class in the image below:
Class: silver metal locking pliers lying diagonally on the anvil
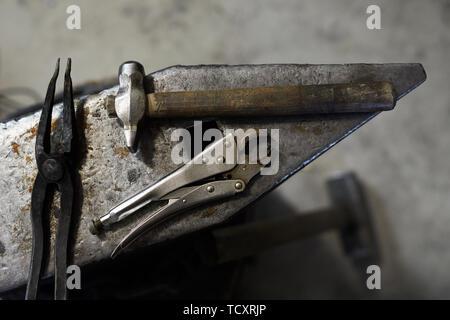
[91,134,268,258]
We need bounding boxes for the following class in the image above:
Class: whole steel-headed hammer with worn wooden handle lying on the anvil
[115,61,396,152]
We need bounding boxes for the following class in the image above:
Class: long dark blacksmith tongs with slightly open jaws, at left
[25,58,76,300]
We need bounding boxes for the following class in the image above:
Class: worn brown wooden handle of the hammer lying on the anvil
[147,82,396,118]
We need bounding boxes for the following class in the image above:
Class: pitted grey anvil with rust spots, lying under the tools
[0,63,426,290]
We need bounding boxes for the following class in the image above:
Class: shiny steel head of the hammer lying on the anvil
[115,61,147,152]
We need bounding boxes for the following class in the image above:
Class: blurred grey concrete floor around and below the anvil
[0,0,450,299]
